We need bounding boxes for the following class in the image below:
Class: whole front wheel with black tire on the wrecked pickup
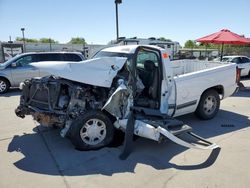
[69,111,115,150]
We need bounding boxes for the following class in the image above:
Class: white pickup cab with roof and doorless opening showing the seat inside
[93,45,174,114]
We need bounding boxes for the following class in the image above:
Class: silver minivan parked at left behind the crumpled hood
[0,52,86,94]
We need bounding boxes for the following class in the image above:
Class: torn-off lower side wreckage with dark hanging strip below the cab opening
[117,107,219,160]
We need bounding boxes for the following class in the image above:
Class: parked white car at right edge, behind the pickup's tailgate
[222,56,250,77]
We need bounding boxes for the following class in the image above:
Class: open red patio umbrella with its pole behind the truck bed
[196,29,250,59]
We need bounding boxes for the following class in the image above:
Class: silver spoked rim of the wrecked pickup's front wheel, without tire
[80,119,107,146]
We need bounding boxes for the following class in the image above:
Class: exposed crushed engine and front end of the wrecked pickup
[15,76,109,135]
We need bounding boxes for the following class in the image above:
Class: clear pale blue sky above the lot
[0,0,250,44]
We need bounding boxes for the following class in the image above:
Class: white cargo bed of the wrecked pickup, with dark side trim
[171,60,237,116]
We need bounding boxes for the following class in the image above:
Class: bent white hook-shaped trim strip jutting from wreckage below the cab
[156,126,219,150]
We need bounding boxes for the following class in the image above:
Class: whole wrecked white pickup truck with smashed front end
[15,45,237,158]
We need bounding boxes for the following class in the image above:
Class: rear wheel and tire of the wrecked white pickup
[195,89,220,120]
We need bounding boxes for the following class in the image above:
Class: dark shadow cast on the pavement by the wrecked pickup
[8,110,250,176]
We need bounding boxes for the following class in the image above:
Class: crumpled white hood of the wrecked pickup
[32,57,127,88]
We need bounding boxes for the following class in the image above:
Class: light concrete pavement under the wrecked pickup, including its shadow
[0,78,250,188]
